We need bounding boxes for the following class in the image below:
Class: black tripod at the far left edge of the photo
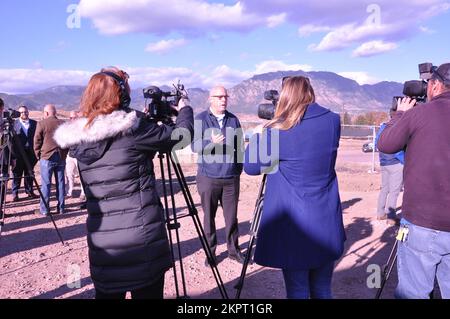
[0,117,65,245]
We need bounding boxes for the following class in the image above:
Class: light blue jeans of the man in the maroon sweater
[395,220,450,299]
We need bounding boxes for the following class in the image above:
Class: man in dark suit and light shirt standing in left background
[12,105,38,202]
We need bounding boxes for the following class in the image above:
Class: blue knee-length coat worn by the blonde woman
[244,104,345,270]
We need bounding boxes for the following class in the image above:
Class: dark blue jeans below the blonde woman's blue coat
[283,261,334,299]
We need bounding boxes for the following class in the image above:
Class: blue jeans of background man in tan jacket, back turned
[39,152,66,214]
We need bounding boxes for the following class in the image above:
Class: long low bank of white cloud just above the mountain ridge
[0,60,312,94]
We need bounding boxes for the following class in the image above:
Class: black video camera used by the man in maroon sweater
[391,63,438,111]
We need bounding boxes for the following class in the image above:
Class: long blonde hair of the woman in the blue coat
[265,76,316,130]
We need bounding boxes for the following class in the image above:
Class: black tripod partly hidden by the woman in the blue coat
[234,175,267,299]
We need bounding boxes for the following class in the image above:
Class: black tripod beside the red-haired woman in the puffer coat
[158,152,228,299]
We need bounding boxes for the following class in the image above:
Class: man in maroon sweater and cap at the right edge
[378,63,450,299]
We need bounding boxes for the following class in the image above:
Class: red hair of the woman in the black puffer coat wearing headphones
[80,67,130,127]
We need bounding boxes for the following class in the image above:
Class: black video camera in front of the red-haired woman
[144,82,187,122]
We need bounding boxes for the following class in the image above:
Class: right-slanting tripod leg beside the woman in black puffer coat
[168,152,228,299]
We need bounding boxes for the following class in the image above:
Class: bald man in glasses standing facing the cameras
[192,86,244,265]
